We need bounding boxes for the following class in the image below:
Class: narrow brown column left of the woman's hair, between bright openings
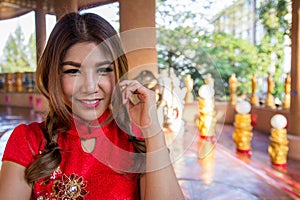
[35,0,46,65]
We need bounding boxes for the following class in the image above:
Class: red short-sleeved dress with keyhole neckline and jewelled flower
[2,112,143,200]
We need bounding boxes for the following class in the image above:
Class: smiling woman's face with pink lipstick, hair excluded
[61,42,115,121]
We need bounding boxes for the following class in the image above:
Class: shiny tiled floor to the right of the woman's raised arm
[174,122,300,200]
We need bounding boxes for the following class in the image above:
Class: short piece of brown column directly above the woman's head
[55,0,78,20]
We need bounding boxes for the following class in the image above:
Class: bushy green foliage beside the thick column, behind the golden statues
[158,27,259,96]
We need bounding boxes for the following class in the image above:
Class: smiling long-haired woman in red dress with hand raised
[0,13,183,200]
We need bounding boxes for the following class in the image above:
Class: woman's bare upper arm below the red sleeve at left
[0,161,31,200]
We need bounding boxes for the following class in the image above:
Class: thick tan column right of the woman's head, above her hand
[119,0,158,77]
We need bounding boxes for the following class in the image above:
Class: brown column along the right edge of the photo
[288,0,300,160]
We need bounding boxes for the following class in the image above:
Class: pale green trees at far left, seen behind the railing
[0,26,36,73]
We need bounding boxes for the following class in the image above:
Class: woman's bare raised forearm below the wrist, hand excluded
[141,127,184,200]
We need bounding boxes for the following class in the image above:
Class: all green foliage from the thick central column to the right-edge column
[157,0,290,100]
